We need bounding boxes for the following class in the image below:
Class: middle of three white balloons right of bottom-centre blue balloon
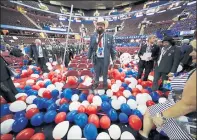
[108,124,121,140]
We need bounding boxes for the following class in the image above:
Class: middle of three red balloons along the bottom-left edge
[16,128,35,140]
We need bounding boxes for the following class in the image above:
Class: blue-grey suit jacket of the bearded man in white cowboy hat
[88,33,116,66]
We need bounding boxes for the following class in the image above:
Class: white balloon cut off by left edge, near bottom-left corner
[1,119,15,134]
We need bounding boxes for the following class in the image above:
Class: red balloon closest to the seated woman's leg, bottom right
[129,115,142,131]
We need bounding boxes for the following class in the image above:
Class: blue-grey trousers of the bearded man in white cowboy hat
[94,58,108,85]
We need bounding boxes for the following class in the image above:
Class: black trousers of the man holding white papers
[137,60,154,81]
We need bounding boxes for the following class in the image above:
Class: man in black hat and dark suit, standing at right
[152,36,181,91]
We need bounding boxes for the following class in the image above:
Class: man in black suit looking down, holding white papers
[137,35,160,81]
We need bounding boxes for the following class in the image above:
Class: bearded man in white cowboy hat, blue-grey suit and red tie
[88,18,116,89]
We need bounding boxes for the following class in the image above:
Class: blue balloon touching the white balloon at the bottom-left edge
[12,117,28,132]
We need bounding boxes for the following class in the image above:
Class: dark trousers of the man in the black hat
[152,67,168,91]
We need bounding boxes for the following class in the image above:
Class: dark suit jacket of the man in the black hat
[157,46,181,73]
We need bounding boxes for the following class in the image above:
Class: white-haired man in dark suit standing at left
[30,39,49,72]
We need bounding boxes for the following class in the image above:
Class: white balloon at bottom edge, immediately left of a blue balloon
[67,125,82,140]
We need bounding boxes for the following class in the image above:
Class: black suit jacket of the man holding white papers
[138,44,160,61]
